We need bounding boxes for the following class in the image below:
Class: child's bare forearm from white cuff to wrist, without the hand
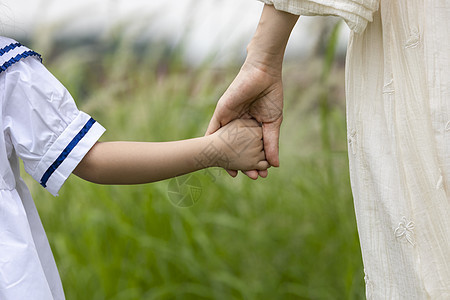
[74,137,210,184]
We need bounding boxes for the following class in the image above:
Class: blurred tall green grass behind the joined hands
[22,29,364,300]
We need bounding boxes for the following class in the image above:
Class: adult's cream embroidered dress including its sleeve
[262,0,450,299]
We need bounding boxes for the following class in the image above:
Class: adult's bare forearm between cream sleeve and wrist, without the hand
[247,5,299,72]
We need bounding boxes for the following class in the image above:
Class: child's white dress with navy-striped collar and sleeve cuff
[0,37,104,300]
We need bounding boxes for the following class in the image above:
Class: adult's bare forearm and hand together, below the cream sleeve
[206,5,298,179]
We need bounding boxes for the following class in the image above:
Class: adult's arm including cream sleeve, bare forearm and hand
[207,0,379,178]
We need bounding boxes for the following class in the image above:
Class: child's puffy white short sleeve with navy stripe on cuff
[1,57,105,195]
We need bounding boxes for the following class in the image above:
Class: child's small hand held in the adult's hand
[210,119,269,171]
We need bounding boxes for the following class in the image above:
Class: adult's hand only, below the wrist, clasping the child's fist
[207,60,283,179]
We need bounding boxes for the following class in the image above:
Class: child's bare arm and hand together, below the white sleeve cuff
[73,120,269,184]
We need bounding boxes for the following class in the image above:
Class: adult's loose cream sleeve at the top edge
[260,0,379,33]
